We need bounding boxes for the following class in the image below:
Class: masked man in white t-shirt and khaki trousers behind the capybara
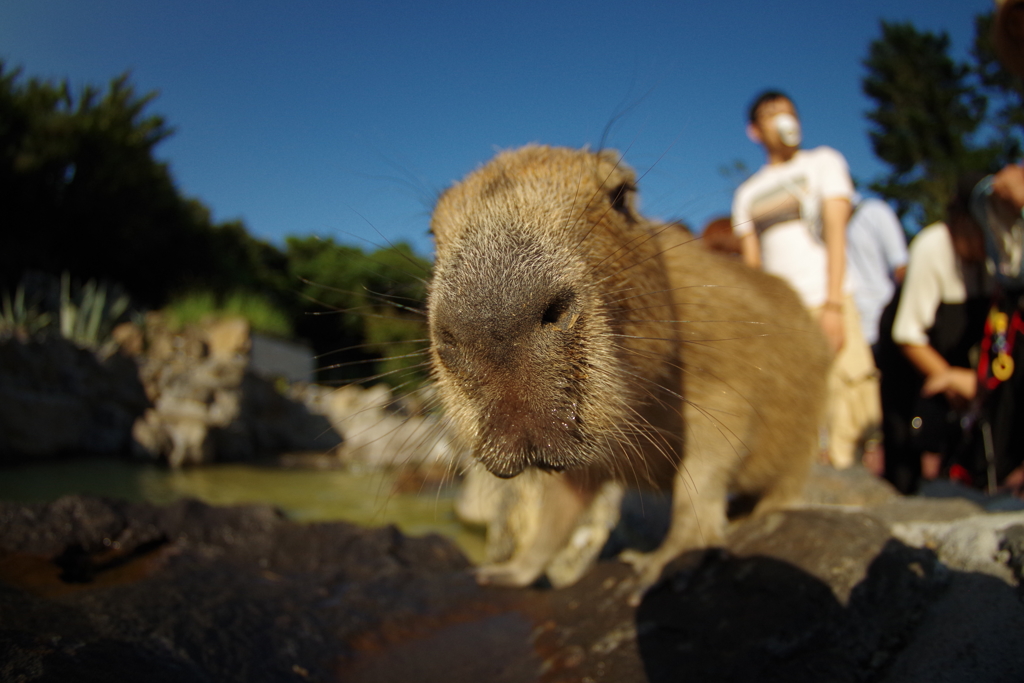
[732,90,882,471]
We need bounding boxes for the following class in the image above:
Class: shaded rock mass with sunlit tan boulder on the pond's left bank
[0,315,341,466]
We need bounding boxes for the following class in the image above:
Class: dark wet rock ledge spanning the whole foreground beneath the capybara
[0,475,1024,683]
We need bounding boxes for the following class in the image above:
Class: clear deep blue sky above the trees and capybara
[0,0,992,255]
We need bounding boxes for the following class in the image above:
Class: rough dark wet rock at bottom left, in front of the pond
[0,498,478,681]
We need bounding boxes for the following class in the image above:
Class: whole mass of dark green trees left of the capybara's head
[0,61,430,384]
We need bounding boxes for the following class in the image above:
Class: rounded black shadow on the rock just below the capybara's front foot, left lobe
[636,554,856,682]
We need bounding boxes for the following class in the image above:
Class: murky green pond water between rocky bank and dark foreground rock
[0,459,483,562]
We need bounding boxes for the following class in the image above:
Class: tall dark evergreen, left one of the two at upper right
[862,22,1002,226]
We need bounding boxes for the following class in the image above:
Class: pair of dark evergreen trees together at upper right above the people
[861,12,1024,226]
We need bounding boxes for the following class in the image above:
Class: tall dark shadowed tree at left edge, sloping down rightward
[0,61,285,305]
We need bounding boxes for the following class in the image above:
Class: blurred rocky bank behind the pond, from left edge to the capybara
[0,313,456,468]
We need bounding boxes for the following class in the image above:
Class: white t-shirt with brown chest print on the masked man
[732,146,853,308]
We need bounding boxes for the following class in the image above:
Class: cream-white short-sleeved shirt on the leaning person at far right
[893,223,984,346]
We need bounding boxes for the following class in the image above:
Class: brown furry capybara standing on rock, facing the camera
[428,146,827,589]
